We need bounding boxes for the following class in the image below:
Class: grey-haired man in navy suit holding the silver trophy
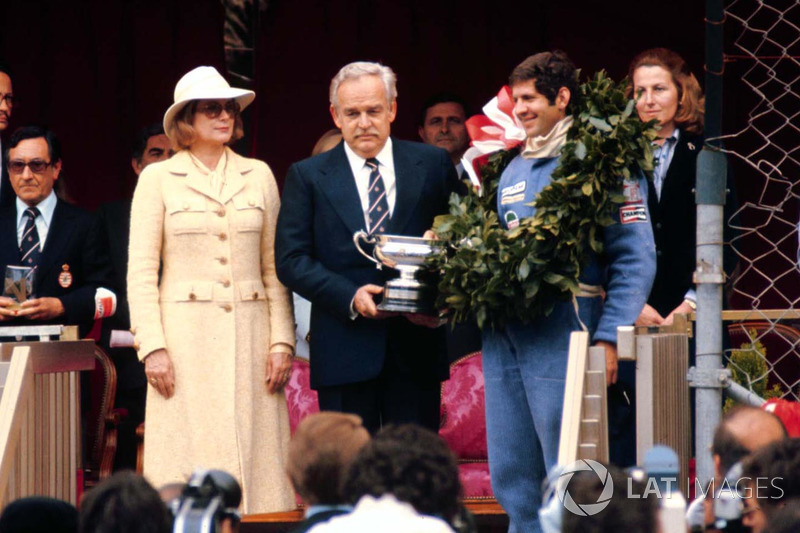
[275,62,458,432]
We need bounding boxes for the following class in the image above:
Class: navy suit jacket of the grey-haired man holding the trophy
[275,139,458,388]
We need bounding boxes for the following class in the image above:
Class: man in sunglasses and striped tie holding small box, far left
[0,126,110,336]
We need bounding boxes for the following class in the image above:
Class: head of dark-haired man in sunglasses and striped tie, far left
[3,126,61,207]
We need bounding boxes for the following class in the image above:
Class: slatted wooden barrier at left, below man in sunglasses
[0,326,94,508]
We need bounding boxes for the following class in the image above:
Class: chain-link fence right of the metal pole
[722,0,800,400]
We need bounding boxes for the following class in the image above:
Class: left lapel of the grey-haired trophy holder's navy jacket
[315,142,366,237]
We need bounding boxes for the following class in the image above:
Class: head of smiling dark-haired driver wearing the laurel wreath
[508,50,578,139]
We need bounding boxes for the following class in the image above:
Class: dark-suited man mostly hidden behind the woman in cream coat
[91,123,173,470]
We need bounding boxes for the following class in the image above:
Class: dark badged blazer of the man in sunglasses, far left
[0,199,112,336]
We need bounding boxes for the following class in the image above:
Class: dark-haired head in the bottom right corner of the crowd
[739,438,800,533]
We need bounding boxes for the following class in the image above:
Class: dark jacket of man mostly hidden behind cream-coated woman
[91,200,147,391]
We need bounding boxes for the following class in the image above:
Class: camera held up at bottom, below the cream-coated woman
[170,470,242,533]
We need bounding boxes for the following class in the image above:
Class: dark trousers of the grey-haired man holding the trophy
[317,350,441,434]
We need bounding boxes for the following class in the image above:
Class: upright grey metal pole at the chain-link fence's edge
[689,0,727,485]
